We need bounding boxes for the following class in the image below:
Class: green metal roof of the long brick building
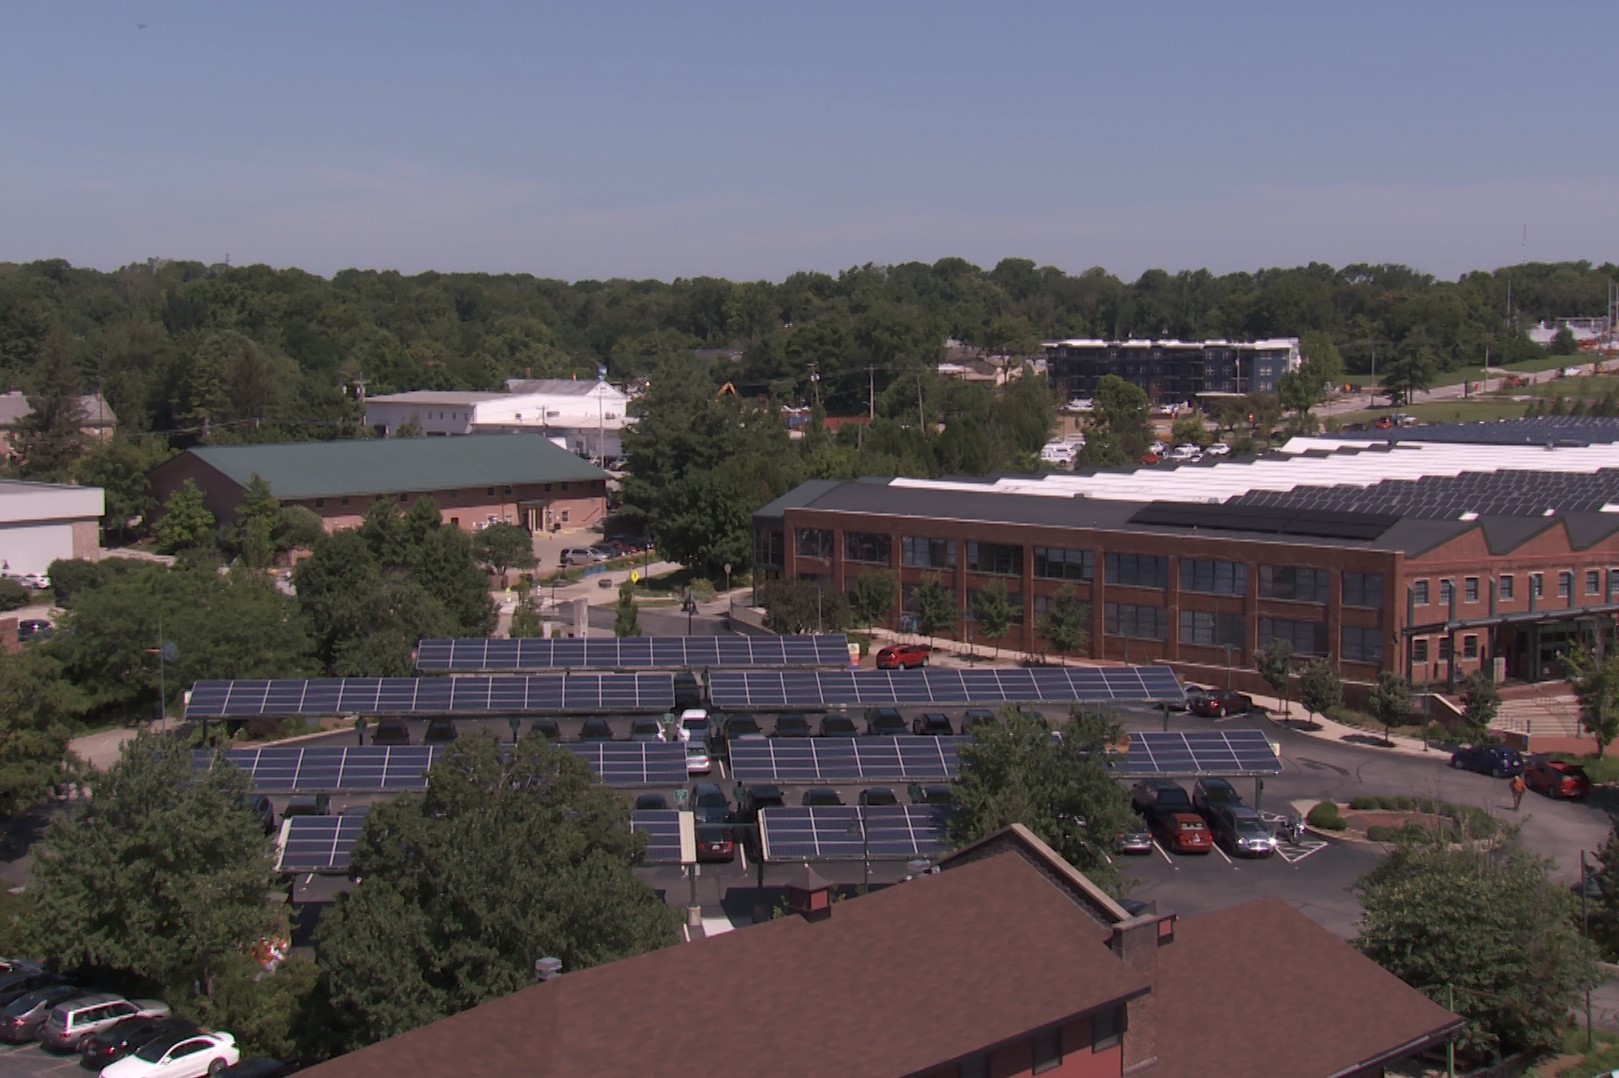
[186,434,607,500]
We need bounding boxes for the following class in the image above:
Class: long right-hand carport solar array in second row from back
[709,667,1185,711]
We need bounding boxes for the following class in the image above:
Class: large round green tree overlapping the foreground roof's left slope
[316,735,677,1047]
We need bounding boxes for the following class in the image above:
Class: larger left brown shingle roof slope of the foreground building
[309,853,1148,1078]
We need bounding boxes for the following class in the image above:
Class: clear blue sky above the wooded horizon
[0,0,1619,280]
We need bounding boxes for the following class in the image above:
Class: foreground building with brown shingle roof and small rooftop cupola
[309,827,1462,1078]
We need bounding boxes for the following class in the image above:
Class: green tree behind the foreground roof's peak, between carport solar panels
[950,709,1133,887]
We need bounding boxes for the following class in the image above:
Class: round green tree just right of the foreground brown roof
[1355,842,1600,1062]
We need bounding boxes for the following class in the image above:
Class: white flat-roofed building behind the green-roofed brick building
[366,379,635,461]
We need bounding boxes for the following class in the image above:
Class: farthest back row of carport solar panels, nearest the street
[416,633,848,673]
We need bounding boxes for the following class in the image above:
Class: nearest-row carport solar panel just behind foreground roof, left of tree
[759,804,950,863]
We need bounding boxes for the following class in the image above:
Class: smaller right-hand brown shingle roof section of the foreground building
[1149,898,1462,1078]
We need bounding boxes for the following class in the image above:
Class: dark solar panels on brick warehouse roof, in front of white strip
[1226,468,1619,520]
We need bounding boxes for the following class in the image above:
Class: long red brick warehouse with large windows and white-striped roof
[753,419,1619,685]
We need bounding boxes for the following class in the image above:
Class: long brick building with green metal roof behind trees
[152,434,607,533]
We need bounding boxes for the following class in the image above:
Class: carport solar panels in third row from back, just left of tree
[730,736,971,783]
